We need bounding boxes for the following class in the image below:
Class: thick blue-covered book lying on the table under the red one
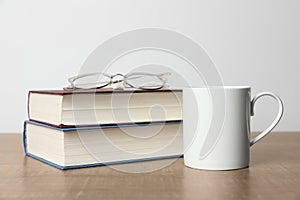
[23,121,183,169]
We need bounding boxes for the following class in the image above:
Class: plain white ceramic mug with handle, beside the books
[183,86,283,170]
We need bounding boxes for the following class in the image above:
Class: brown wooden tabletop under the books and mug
[0,133,300,200]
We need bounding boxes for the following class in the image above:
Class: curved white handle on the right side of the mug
[250,92,283,146]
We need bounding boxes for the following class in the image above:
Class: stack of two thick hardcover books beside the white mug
[23,89,183,169]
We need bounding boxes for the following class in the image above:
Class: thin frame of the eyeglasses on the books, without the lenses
[63,72,171,90]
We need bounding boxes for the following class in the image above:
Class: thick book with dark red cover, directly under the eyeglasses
[28,89,182,127]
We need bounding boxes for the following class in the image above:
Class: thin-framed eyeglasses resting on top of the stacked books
[64,72,171,90]
